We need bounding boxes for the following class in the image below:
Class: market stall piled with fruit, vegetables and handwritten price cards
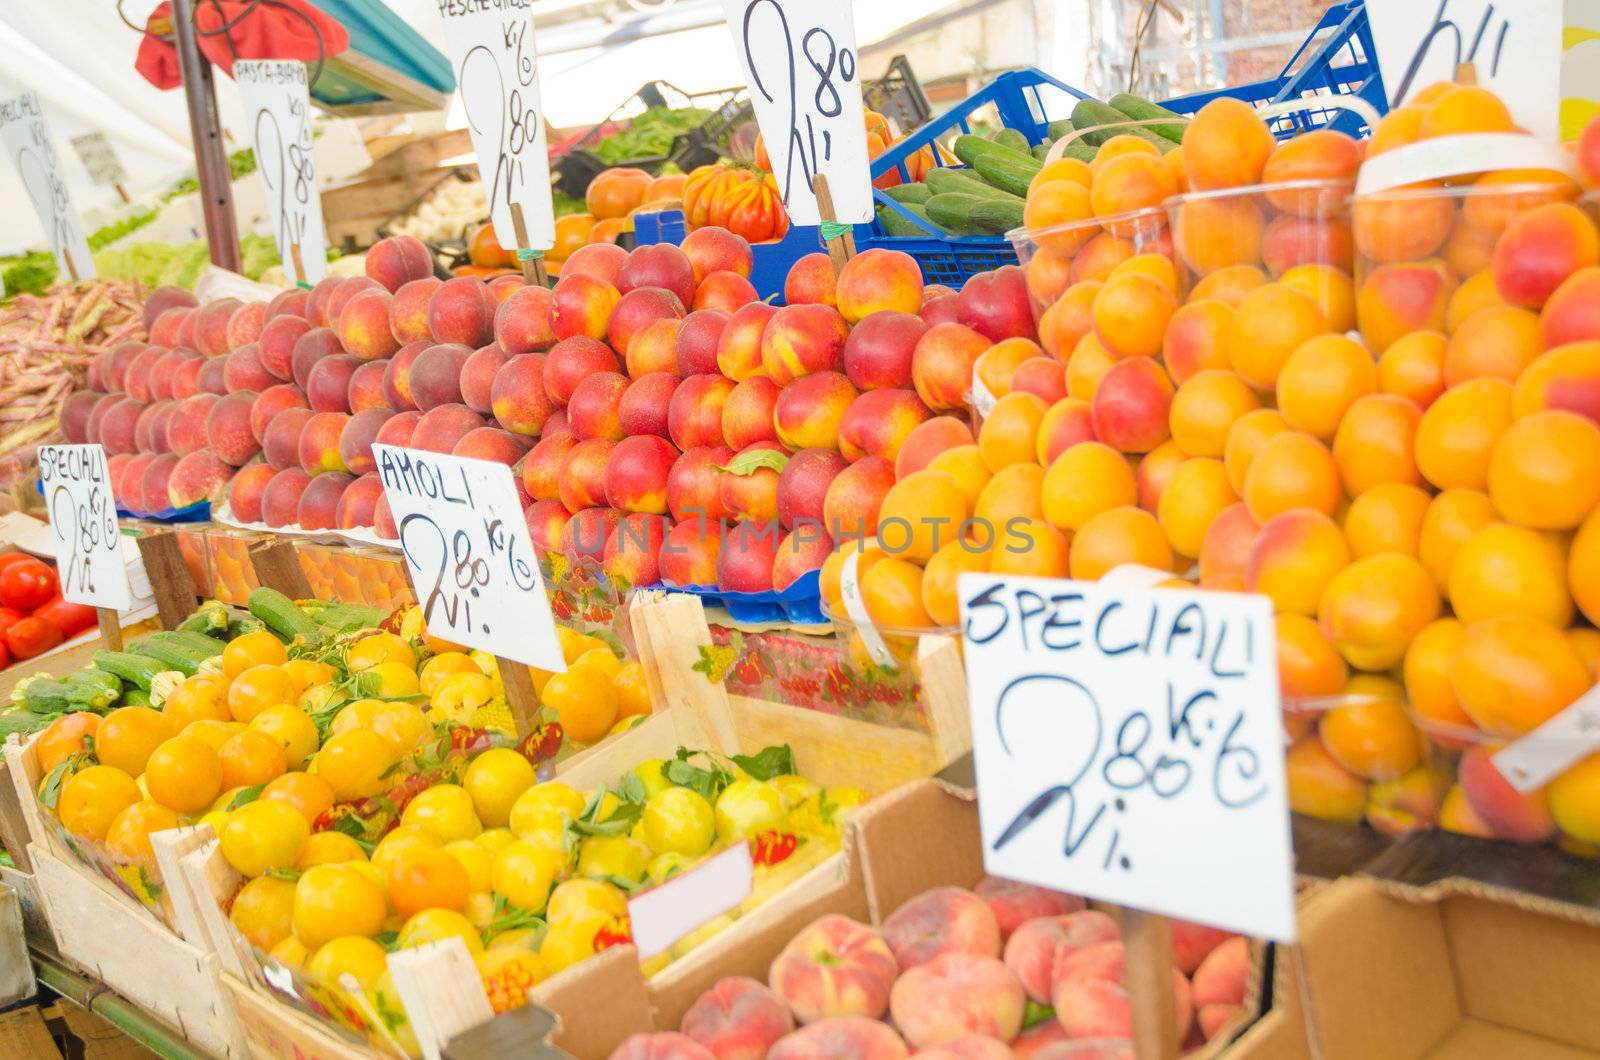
[0,0,1600,1060]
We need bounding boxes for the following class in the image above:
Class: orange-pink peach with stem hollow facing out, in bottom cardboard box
[764,915,899,1023]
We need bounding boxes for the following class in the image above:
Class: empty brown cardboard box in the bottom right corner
[1301,877,1600,1060]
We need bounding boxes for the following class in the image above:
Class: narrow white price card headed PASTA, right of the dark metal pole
[234,59,328,285]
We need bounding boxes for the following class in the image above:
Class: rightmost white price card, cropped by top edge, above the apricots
[1366,0,1565,139]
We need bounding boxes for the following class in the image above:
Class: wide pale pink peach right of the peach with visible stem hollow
[890,953,1027,1049]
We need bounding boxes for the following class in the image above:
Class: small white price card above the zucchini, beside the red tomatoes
[38,445,133,612]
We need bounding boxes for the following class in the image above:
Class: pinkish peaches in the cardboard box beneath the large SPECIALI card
[611,876,1251,1060]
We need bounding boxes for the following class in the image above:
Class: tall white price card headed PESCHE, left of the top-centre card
[438,0,555,250]
